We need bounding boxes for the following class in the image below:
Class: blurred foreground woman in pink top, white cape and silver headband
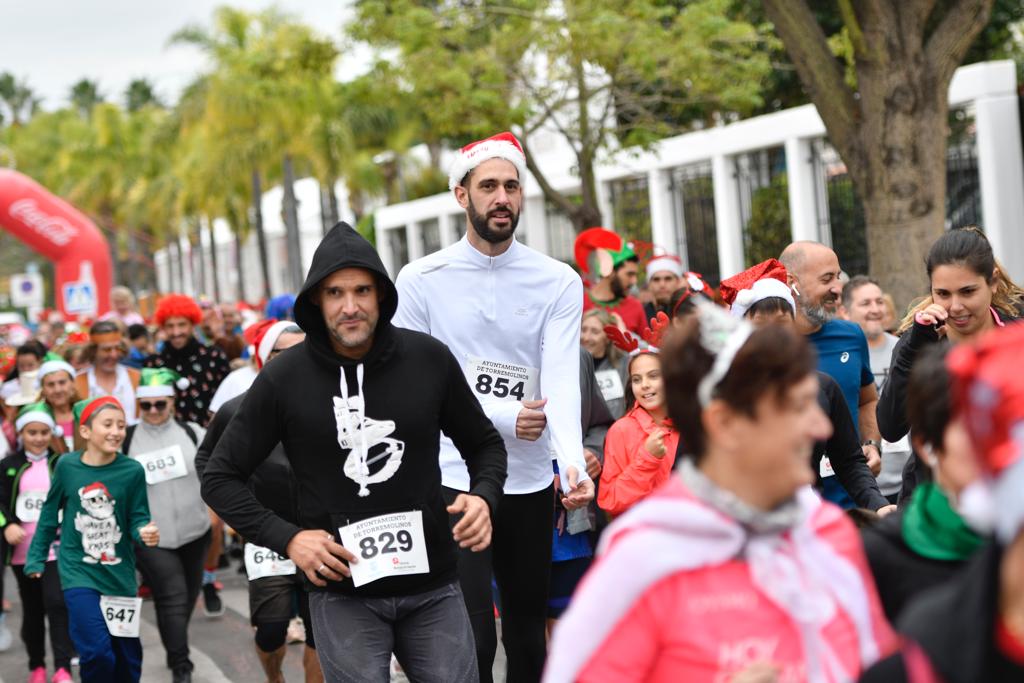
[545,302,896,683]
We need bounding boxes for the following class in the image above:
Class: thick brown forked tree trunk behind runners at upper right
[764,0,993,308]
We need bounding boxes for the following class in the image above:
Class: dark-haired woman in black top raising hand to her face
[878,227,1024,503]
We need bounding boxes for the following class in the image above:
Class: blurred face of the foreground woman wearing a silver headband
[728,374,831,510]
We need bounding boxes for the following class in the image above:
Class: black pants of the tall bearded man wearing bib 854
[443,486,554,683]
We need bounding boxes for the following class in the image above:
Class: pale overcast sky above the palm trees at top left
[0,0,366,110]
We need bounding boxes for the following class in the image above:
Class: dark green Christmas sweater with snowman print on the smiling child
[25,451,150,597]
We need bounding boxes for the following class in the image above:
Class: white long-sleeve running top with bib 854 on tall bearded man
[393,237,588,494]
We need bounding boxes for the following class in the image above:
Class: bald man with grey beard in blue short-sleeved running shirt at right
[779,242,882,509]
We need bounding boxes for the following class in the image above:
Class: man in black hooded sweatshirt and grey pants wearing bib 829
[203,223,506,681]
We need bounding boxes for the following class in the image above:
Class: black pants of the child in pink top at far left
[11,562,75,673]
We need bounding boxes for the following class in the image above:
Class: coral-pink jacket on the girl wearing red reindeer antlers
[597,405,679,515]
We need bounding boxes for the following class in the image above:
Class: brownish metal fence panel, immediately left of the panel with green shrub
[669,162,721,283]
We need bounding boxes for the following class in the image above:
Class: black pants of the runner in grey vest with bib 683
[135,531,210,671]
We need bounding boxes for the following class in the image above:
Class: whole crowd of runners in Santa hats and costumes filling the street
[0,133,1024,683]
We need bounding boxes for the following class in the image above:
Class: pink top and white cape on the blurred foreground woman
[544,477,896,683]
